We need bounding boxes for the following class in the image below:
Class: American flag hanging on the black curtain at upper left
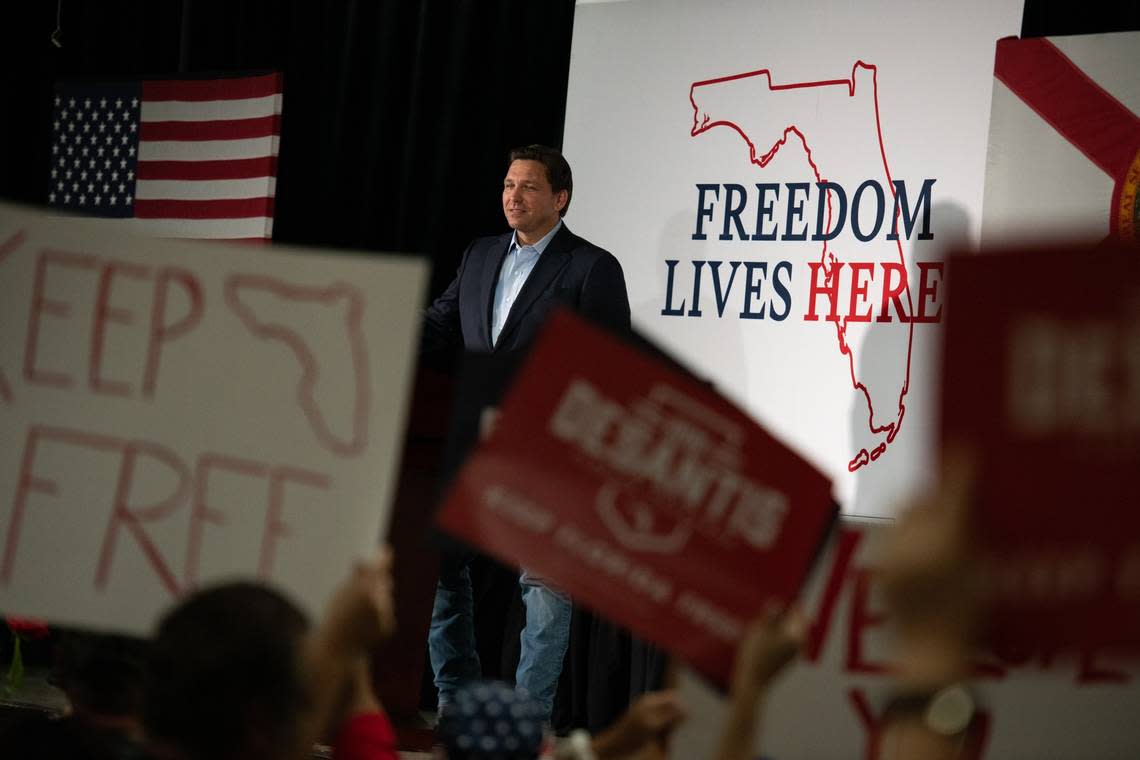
[48,73,282,240]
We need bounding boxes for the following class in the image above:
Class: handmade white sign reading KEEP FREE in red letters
[0,205,426,634]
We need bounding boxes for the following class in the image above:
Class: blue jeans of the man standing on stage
[428,556,571,718]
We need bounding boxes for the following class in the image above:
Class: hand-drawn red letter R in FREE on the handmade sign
[95,441,190,596]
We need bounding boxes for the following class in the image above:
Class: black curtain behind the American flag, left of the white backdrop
[0,0,573,303]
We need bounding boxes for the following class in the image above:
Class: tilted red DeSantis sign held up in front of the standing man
[439,312,836,685]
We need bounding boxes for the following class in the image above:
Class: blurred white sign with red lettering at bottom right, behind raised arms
[670,520,1140,760]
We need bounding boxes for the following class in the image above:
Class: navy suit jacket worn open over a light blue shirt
[422,223,629,353]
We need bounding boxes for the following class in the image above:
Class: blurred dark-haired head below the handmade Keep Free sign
[143,583,309,758]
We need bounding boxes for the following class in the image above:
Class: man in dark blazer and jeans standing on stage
[423,145,629,716]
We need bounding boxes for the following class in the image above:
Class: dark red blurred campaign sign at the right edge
[942,246,1140,654]
